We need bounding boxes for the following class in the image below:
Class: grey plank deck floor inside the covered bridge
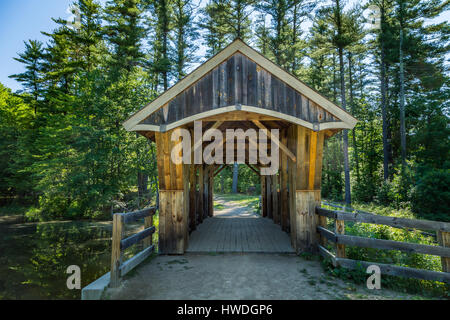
[187,201,294,253]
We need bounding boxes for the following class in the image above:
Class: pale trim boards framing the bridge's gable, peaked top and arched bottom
[123,39,357,131]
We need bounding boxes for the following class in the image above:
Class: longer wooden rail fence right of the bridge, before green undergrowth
[316,204,450,283]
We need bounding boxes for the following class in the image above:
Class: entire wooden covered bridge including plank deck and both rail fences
[79,40,450,298]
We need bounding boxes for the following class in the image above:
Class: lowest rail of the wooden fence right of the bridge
[336,258,450,283]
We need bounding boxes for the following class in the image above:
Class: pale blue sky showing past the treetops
[0,0,450,91]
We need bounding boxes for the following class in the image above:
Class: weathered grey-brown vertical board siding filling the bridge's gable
[141,53,340,125]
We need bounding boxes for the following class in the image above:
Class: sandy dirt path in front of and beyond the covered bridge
[105,195,428,300]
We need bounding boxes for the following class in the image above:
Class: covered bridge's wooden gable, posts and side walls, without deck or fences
[124,40,357,254]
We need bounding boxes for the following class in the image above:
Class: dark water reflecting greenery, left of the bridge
[0,217,112,300]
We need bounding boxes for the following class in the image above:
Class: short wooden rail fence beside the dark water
[110,207,156,288]
